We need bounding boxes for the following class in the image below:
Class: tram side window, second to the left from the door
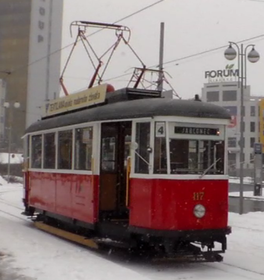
[58,130,72,169]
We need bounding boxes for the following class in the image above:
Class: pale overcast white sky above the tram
[62,0,264,98]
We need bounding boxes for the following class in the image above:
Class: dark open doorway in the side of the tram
[99,122,132,221]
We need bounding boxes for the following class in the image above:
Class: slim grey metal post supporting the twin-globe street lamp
[239,44,246,215]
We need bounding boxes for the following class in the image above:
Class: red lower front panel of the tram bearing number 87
[130,179,228,230]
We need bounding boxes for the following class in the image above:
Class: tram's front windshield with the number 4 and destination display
[153,122,225,176]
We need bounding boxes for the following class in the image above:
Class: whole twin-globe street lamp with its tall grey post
[225,42,260,215]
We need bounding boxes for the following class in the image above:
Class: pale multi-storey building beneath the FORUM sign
[202,81,264,176]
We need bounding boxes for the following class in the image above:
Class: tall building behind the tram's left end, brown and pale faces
[0,0,63,151]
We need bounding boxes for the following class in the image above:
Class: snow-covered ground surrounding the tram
[0,180,264,280]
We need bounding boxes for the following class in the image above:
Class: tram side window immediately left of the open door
[74,127,93,170]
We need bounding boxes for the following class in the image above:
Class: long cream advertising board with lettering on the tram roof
[42,85,107,117]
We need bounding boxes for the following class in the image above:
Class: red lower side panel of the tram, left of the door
[29,172,99,223]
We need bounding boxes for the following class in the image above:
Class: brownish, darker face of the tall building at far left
[0,0,31,148]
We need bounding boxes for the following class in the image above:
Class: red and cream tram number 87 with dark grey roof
[24,85,233,261]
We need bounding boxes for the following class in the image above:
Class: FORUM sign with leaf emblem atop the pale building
[205,64,239,83]
